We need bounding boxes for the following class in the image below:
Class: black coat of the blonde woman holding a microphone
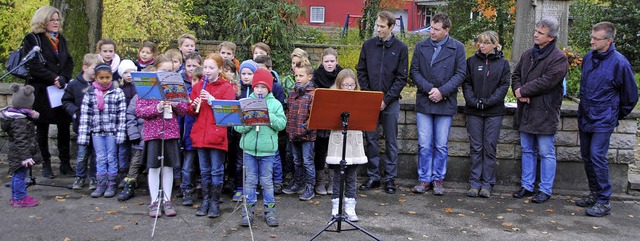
[22,33,73,123]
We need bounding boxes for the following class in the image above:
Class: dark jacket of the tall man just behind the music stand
[356,36,409,105]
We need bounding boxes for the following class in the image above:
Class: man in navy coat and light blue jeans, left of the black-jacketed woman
[411,13,467,195]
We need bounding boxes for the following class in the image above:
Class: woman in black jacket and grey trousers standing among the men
[462,31,510,197]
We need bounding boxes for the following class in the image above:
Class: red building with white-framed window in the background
[298,0,443,31]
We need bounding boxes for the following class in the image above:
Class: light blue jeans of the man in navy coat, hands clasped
[416,113,453,182]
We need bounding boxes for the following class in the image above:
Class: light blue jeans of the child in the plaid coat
[91,135,118,176]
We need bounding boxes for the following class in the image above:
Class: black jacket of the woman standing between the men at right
[462,50,511,116]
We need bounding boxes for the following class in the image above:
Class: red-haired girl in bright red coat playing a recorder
[189,53,235,218]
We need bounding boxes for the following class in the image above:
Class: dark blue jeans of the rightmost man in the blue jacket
[580,131,613,203]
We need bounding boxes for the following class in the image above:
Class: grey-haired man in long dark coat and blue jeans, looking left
[511,18,568,203]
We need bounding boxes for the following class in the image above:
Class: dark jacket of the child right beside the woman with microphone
[62,72,89,134]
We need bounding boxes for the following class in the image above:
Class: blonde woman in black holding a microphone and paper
[22,6,75,178]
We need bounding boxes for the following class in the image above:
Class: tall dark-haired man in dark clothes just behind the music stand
[356,11,409,194]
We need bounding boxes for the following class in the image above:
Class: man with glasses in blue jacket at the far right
[576,22,638,217]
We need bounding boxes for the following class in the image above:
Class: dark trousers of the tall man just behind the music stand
[365,101,400,180]
